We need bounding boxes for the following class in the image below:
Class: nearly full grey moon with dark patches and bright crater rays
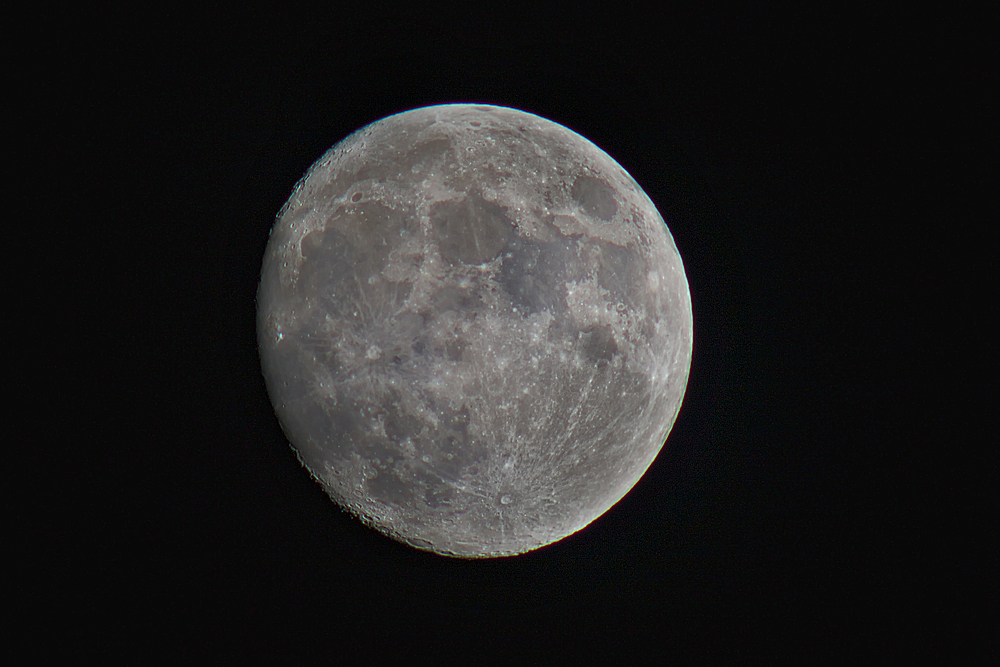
[257,104,693,558]
